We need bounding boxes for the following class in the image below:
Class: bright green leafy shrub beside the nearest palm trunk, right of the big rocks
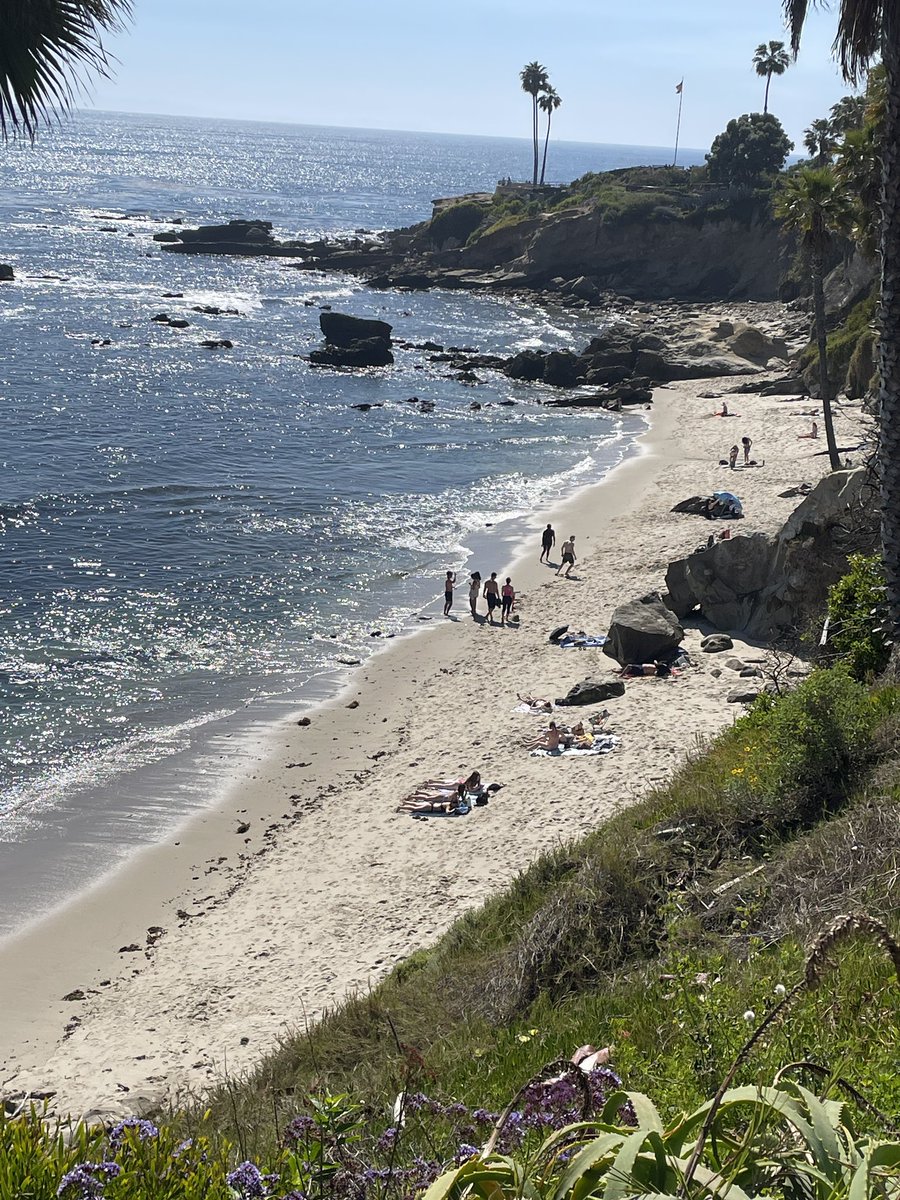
[828,554,889,679]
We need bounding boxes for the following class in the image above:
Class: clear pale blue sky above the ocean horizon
[82,0,859,150]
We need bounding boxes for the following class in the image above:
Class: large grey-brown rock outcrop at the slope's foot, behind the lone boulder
[665,468,865,640]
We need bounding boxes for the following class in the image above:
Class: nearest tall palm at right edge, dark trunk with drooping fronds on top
[784,0,900,637]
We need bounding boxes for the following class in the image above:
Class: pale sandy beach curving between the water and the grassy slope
[0,305,860,1112]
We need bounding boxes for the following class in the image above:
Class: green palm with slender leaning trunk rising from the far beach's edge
[775,167,852,470]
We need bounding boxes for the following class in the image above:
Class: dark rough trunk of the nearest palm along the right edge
[877,5,900,644]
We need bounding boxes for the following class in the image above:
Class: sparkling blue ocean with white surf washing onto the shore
[0,113,698,935]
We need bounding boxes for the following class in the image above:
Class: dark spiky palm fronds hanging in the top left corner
[0,0,131,138]
